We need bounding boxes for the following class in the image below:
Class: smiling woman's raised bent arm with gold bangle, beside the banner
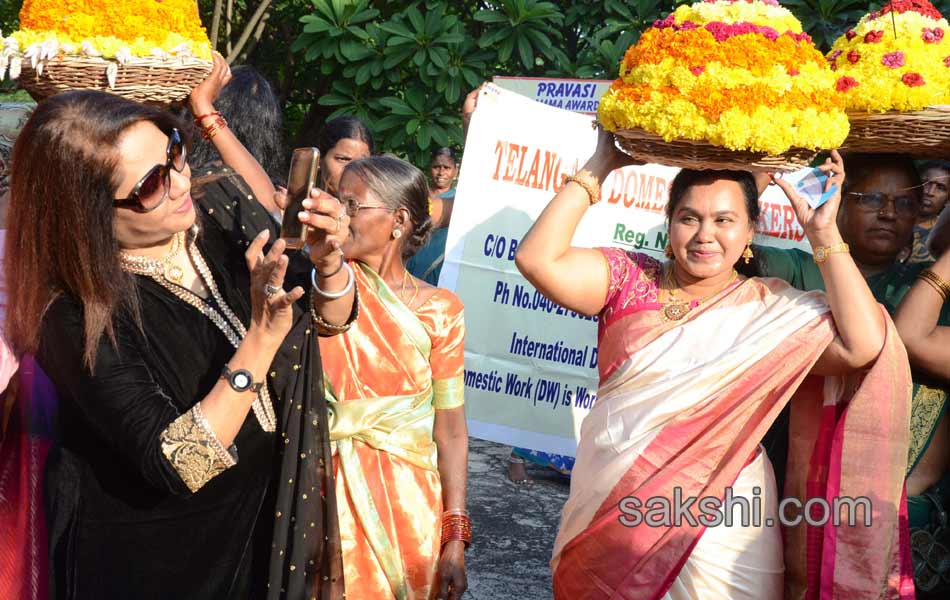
[515,130,634,315]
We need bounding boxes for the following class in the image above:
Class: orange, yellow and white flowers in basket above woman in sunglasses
[0,0,211,79]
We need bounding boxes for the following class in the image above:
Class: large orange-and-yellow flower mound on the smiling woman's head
[598,0,849,156]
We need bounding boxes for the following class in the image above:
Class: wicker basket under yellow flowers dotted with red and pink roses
[842,104,950,159]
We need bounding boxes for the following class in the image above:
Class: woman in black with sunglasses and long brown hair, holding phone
[5,55,355,599]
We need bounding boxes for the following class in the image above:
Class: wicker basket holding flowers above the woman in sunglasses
[19,56,211,106]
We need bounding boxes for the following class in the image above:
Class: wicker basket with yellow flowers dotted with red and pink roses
[827,0,950,157]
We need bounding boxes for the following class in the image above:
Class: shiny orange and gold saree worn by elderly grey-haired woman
[320,263,465,600]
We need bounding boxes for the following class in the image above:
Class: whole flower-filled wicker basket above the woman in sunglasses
[0,0,212,105]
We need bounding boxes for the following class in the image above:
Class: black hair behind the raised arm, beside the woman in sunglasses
[186,65,287,181]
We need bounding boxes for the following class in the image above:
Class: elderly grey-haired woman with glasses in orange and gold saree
[320,157,470,600]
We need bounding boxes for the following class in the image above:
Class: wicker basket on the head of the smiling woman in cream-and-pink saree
[614,129,818,173]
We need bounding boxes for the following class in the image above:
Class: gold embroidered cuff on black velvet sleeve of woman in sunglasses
[161,404,237,492]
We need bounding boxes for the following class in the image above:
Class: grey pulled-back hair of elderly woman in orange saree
[343,156,432,258]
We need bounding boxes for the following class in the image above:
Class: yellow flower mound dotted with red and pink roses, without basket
[828,0,950,112]
